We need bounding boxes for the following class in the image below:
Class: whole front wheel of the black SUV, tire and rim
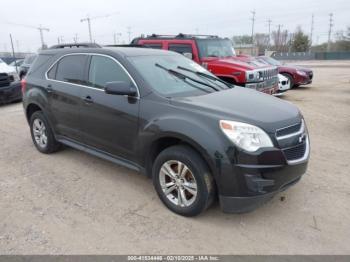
[152,145,215,217]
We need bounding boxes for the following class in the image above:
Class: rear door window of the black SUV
[55,55,88,85]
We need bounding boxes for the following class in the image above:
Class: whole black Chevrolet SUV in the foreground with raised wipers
[22,44,310,216]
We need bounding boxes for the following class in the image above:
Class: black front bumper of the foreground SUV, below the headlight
[217,129,310,213]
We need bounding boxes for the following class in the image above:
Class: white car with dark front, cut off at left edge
[0,59,22,104]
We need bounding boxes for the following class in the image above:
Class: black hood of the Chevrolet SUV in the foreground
[171,87,301,133]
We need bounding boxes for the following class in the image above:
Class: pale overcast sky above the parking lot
[0,0,350,52]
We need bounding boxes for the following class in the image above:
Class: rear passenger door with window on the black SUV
[47,54,88,142]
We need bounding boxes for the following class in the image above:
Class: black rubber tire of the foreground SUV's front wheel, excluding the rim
[152,146,213,216]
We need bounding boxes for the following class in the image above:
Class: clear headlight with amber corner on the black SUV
[220,120,273,152]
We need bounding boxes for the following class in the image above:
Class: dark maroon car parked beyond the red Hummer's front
[257,56,314,88]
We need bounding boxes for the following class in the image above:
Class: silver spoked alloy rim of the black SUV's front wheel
[159,160,197,207]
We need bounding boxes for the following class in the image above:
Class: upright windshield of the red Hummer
[197,39,236,58]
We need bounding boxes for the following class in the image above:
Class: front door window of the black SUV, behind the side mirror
[88,55,131,88]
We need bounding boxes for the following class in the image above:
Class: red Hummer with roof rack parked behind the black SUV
[131,34,278,94]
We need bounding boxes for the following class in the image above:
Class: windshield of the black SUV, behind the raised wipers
[129,54,228,97]
